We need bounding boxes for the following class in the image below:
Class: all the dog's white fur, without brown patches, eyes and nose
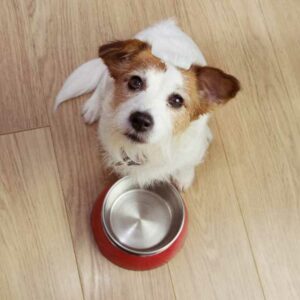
[55,20,212,189]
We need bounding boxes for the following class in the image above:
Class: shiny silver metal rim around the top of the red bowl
[100,176,186,256]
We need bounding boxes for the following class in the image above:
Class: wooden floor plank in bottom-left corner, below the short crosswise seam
[0,128,83,300]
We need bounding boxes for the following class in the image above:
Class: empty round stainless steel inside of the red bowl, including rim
[101,177,185,255]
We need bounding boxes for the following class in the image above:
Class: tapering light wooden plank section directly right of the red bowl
[169,120,264,300]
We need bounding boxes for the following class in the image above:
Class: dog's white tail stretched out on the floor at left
[54,58,107,110]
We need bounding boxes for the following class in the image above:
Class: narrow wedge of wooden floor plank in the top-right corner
[259,0,300,122]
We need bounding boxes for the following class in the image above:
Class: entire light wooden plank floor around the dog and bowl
[0,0,300,300]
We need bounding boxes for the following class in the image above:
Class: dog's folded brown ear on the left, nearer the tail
[99,39,149,77]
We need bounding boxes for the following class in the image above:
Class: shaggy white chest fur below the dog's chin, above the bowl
[99,106,212,189]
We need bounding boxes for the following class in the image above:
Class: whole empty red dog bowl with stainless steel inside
[91,177,187,270]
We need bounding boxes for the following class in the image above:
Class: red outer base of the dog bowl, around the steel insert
[91,187,187,271]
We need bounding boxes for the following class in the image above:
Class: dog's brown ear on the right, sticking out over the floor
[193,66,240,104]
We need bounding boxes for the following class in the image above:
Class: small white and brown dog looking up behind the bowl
[55,20,239,190]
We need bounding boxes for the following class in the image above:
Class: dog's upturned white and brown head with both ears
[99,40,239,143]
